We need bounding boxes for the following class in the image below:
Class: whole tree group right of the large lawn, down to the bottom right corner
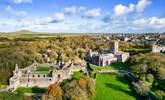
[129,53,165,100]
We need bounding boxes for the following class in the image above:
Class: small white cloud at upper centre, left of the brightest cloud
[84,8,100,18]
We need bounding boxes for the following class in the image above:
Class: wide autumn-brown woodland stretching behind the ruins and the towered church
[0,35,152,84]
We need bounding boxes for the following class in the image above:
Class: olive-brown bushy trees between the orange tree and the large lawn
[63,76,95,100]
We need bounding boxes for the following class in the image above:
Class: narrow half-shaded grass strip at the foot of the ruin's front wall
[14,87,46,93]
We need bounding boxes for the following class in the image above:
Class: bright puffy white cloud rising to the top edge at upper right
[114,0,151,16]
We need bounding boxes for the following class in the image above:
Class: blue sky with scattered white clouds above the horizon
[0,0,165,33]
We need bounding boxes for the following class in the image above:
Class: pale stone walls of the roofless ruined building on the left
[9,64,81,90]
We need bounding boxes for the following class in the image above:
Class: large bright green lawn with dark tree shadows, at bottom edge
[95,74,136,100]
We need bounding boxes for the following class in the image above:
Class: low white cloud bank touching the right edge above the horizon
[133,17,165,28]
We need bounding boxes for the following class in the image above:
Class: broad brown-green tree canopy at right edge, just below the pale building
[129,53,165,80]
